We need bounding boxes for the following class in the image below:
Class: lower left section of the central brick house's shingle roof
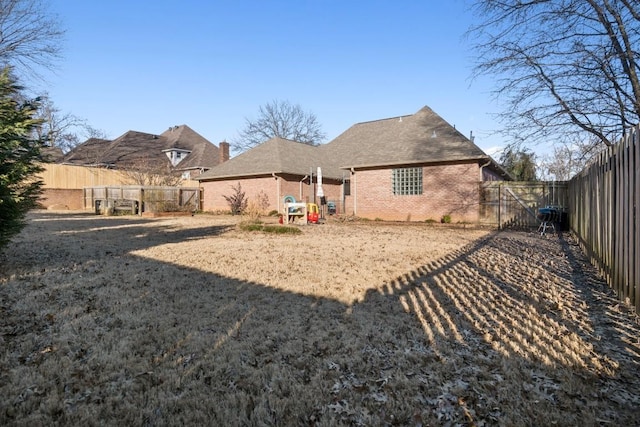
[195,137,342,180]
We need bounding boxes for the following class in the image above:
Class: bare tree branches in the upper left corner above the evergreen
[0,0,64,76]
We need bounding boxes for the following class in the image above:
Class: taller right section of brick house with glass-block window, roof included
[323,107,509,222]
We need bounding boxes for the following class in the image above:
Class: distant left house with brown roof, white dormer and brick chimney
[59,125,229,179]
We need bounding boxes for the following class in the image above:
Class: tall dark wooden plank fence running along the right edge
[569,126,640,313]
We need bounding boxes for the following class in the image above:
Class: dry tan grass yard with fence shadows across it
[0,211,640,426]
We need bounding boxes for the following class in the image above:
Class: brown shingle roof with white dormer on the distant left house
[62,125,219,170]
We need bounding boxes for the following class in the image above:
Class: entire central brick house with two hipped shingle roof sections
[196,107,510,222]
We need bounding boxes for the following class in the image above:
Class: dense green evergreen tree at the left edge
[0,68,42,248]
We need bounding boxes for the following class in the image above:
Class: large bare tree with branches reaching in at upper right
[468,0,640,150]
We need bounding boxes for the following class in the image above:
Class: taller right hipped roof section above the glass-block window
[325,107,496,168]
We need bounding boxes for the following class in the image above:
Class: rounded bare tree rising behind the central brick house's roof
[234,100,325,151]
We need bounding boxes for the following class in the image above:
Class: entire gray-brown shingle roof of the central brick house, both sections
[197,107,504,180]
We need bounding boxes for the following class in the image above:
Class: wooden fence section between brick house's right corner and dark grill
[479,181,568,228]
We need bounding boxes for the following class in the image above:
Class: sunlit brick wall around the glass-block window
[351,163,480,222]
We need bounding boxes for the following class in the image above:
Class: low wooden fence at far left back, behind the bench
[83,185,202,215]
